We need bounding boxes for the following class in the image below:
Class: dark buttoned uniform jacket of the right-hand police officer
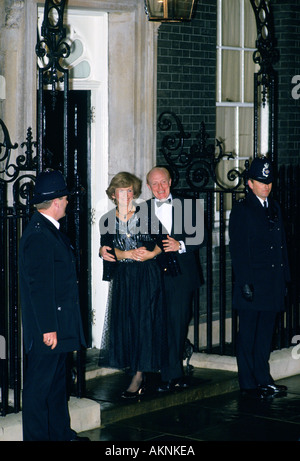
[229,191,290,311]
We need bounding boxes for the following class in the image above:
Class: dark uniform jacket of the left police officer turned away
[19,211,85,353]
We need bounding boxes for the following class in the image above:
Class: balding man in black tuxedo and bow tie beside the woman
[147,167,204,392]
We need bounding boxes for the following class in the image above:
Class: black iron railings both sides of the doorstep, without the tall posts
[0,113,300,416]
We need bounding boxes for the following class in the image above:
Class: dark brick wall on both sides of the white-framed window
[157,0,300,169]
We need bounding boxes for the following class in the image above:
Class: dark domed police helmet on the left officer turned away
[31,169,69,205]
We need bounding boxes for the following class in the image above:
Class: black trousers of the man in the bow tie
[161,276,193,381]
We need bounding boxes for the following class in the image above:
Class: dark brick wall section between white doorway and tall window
[157,0,217,163]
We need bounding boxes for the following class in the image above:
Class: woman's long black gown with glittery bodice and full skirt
[99,214,167,374]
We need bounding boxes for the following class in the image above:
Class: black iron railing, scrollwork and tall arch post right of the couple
[158,0,300,355]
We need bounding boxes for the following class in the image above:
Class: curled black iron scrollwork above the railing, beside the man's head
[158,111,249,192]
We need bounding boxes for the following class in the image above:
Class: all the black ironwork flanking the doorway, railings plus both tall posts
[0,0,300,416]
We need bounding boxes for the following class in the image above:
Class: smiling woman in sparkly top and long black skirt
[99,172,167,398]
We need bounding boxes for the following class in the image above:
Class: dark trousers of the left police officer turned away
[22,350,75,441]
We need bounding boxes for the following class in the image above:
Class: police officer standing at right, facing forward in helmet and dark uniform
[229,157,290,398]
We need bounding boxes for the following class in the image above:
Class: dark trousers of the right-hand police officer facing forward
[237,309,277,389]
